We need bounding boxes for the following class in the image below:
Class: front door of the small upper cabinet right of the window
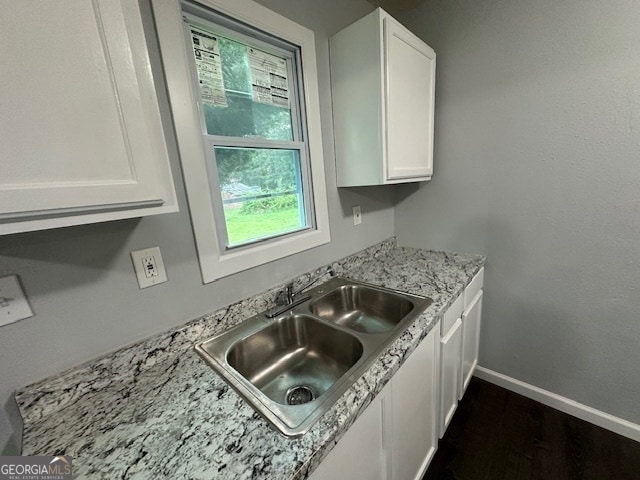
[384,17,436,181]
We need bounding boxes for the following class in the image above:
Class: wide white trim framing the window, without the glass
[152,0,330,283]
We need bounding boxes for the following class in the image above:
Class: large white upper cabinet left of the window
[0,0,177,234]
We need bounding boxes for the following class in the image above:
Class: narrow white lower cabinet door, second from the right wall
[440,318,462,438]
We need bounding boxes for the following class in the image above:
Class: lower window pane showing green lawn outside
[215,147,308,247]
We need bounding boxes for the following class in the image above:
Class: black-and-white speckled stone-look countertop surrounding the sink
[16,238,485,480]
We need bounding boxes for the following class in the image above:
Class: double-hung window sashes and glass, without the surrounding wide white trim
[184,13,313,249]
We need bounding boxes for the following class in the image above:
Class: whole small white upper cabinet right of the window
[330,8,436,187]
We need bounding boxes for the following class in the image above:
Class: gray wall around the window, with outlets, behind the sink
[0,0,384,454]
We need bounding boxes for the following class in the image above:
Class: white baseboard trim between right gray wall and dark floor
[474,366,640,442]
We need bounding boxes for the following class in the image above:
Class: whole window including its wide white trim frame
[153,0,329,282]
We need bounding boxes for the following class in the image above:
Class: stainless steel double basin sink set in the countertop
[195,278,432,437]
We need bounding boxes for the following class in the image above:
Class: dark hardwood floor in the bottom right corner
[422,378,640,480]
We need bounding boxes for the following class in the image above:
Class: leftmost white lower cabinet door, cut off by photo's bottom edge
[309,389,387,480]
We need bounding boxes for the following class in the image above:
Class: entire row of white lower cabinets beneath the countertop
[310,268,484,480]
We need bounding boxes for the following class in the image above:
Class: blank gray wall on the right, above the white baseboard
[396,0,640,423]
